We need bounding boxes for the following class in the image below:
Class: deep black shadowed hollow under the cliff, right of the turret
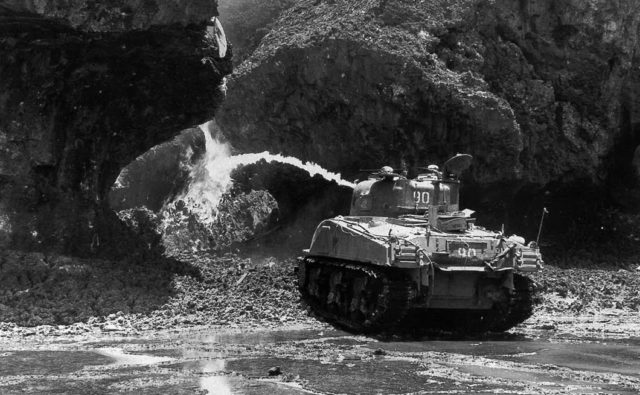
[461,178,640,267]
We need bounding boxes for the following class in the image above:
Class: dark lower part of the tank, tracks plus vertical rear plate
[298,257,536,335]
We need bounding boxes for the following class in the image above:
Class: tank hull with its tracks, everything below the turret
[298,217,541,333]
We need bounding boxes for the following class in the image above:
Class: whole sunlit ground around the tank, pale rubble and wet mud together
[0,248,640,394]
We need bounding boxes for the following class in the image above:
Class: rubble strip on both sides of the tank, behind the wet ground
[0,251,640,338]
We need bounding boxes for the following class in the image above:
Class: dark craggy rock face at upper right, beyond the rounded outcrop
[480,1,640,183]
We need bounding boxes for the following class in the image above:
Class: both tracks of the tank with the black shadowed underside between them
[298,258,538,336]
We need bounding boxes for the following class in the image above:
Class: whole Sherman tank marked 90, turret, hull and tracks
[298,154,543,333]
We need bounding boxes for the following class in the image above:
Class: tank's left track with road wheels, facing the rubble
[298,258,415,333]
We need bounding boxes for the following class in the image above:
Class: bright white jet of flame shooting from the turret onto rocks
[165,121,354,223]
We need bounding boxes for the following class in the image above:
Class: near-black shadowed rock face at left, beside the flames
[0,6,231,255]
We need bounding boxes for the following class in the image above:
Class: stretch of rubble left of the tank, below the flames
[0,252,312,335]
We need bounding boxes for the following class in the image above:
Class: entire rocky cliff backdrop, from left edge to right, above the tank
[0,0,640,252]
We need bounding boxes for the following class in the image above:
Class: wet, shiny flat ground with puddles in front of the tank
[0,329,640,394]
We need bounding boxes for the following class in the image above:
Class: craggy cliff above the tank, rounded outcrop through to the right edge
[218,0,640,192]
